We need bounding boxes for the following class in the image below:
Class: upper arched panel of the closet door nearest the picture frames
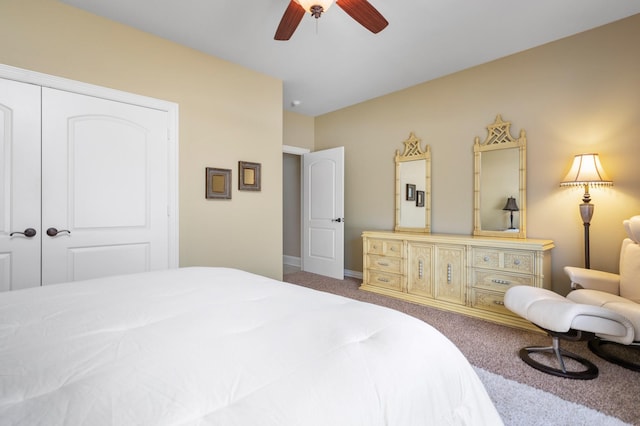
[72,117,149,229]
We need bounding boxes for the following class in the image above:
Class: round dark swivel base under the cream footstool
[518,330,598,380]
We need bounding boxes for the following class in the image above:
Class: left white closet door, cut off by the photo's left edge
[0,79,41,291]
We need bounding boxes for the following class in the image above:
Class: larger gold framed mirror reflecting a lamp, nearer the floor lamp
[473,114,527,238]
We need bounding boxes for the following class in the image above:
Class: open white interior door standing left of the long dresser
[302,147,344,279]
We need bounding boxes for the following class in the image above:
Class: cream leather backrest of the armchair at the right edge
[620,216,640,303]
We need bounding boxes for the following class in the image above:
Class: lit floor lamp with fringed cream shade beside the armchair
[560,154,613,269]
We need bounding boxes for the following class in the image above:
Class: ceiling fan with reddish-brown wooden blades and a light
[274,0,389,40]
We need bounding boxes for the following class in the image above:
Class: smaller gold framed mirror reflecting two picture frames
[395,132,431,233]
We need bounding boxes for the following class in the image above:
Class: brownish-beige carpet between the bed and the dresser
[284,272,640,425]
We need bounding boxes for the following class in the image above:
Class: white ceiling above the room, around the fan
[61,0,640,116]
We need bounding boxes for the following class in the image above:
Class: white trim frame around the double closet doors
[0,64,179,268]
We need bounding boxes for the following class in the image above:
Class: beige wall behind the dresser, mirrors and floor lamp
[315,15,640,292]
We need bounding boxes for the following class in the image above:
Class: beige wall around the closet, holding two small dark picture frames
[0,0,283,278]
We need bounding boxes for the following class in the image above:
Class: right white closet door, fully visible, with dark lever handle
[42,88,169,284]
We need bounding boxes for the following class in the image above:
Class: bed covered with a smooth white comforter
[0,268,501,426]
